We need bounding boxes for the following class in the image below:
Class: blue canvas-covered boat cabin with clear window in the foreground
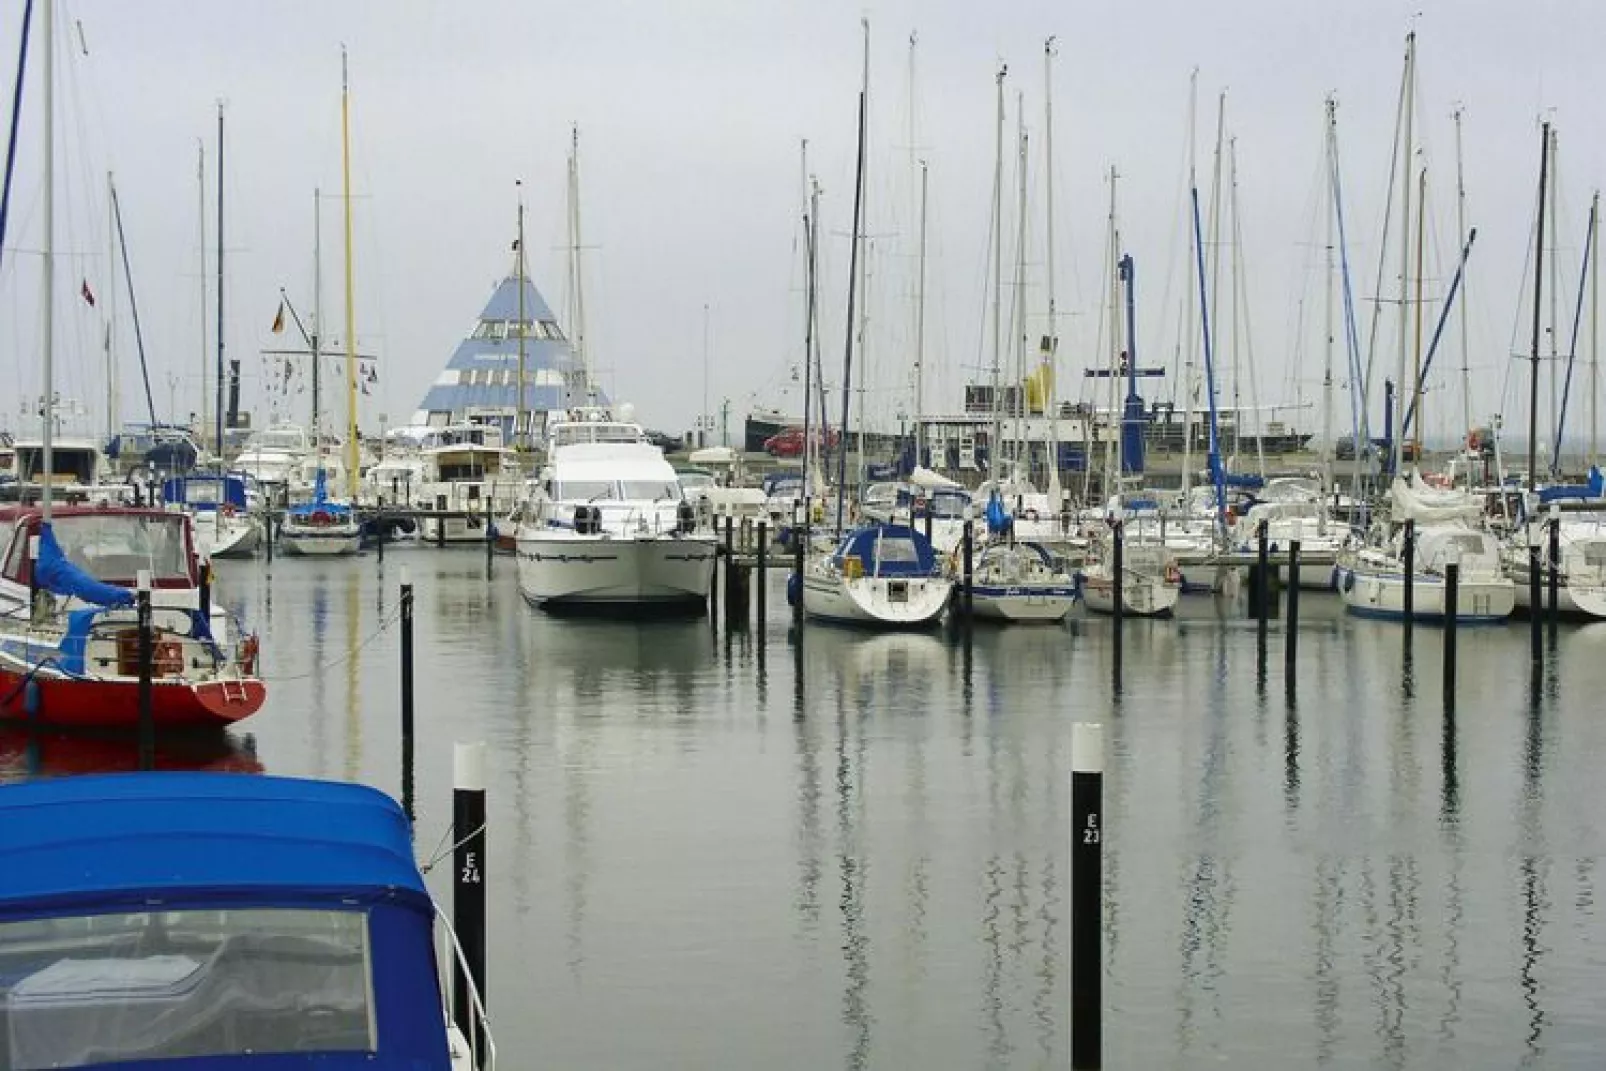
[0,772,451,1071]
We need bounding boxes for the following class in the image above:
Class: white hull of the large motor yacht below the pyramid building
[517,528,716,610]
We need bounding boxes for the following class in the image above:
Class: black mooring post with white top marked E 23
[1071,723,1103,1069]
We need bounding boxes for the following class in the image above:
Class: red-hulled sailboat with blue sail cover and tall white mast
[0,0,267,729]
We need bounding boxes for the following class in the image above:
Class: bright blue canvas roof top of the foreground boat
[0,772,432,920]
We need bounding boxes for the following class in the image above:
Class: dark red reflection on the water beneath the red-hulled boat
[0,729,263,784]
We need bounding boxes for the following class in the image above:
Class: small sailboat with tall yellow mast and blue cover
[279,50,363,557]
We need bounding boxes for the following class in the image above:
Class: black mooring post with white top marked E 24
[451,743,485,1060]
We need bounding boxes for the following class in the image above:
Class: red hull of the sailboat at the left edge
[0,670,268,729]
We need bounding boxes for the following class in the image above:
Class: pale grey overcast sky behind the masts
[0,0,1606,452]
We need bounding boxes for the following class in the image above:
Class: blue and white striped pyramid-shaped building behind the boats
[413,275,607,443]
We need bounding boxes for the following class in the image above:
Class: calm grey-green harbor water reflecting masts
[0,549,1606,1069]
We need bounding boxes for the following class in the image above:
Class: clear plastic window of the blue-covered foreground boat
[0,907,377,1071]
